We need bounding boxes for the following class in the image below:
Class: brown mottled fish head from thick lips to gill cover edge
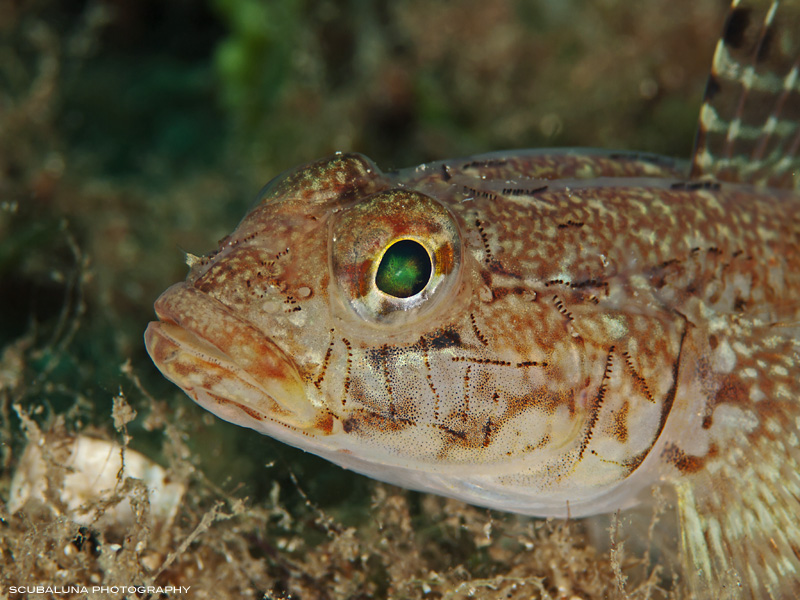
[145,155,675,515]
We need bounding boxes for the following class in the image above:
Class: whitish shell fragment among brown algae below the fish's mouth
[8,436,185,526]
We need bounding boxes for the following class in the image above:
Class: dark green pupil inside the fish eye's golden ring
[375,240,432,298]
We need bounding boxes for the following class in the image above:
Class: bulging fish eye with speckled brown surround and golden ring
[330,189,462,325]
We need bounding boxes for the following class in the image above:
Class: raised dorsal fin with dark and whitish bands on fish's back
[692,0,800,189]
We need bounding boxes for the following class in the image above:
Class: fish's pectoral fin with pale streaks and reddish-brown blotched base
[677,324,800,600]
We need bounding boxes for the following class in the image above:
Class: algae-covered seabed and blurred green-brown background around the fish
[0,0,726,599]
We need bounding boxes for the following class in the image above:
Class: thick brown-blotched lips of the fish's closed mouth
[144,283,318,435]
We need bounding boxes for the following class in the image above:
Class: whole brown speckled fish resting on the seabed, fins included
[146,2,800,598]
